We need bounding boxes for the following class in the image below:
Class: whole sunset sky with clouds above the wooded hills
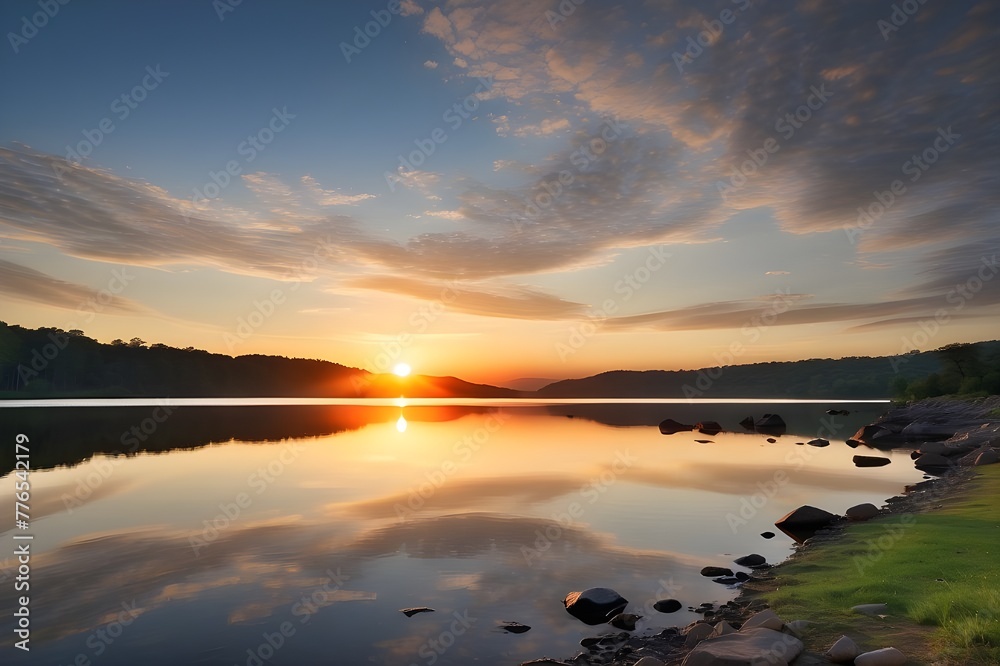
[0,0,1000,383]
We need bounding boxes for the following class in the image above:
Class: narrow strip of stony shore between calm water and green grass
[522,396,1000,666]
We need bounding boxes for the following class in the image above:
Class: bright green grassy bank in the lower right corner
[758,465,1000,664]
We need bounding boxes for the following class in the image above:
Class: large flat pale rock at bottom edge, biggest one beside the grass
[681,627,805,666]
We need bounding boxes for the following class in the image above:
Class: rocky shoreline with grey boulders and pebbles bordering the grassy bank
[522,396,1000,666]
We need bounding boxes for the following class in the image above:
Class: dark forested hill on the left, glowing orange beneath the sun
[0,322,519,399]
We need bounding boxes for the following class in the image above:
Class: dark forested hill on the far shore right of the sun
[536,341,1000,399]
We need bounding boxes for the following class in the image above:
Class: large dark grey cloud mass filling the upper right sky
[410,0,1000,262]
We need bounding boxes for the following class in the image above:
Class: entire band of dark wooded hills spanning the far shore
[0,322,1000,399]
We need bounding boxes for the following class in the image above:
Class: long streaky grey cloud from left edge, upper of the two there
[0,148,360,278]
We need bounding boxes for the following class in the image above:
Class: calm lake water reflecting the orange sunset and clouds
[0,400,921,666]
